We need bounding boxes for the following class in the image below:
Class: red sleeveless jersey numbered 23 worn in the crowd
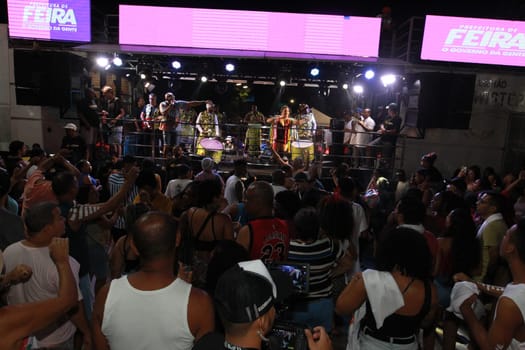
[248,217,290,263]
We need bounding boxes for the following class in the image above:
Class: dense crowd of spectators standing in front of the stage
[0,107,525,349]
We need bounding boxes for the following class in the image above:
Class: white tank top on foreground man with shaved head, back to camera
[101,276,194,350]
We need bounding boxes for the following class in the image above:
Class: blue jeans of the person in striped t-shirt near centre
[286,297,334,332]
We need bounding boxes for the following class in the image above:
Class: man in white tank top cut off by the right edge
[460,219,525,350]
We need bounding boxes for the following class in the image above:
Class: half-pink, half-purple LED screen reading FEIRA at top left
[7,0,91,42]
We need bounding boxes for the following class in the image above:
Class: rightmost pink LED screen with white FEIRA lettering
[421,16,525,66]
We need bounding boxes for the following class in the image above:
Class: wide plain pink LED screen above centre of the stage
[119,5,381,57]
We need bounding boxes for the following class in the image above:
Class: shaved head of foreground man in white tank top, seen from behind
[133,212,178,261]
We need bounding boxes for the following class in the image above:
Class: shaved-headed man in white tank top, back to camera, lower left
[93,212,215,350]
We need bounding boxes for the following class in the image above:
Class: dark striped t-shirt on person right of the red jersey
[288,237,344,299]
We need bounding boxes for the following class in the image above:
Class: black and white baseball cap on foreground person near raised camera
[215,260,292,323]
